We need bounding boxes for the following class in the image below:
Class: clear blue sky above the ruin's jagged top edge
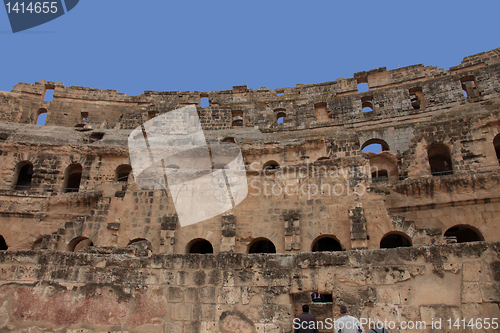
[0,0,500,95]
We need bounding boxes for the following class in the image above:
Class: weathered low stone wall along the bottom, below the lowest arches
[0,243,500,333]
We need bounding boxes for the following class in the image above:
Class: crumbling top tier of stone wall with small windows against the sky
[0,49,500,131]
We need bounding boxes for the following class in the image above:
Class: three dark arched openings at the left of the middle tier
[13,161,132,193]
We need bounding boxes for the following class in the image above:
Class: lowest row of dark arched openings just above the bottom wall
[48,225,484,254]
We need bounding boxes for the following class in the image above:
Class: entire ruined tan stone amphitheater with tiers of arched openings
[0,48,500,333]
